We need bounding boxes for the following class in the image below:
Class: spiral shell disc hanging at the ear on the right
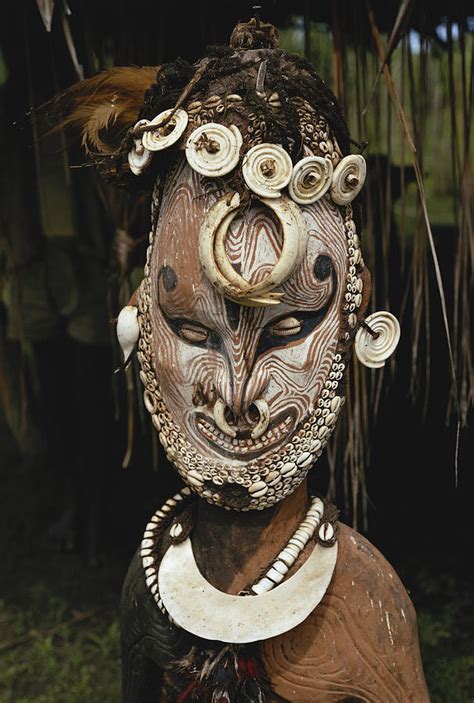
[355,311,400,369]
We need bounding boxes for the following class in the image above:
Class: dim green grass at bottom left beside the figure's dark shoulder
[0,568,120,703]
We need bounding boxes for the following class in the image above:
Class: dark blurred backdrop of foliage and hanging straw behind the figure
[0,0,474,703]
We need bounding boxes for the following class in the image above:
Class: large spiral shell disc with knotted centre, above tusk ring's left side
[186,122,243,178]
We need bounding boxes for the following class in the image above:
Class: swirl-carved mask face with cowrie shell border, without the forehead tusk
[139,160,362,510]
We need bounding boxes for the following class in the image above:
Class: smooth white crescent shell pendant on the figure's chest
[158,537,337,644]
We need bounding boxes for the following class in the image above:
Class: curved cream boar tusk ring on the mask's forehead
[199,193,308,307]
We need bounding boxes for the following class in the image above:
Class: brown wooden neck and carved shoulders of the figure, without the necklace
[122,485,429,703]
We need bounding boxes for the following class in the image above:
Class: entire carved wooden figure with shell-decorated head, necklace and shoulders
[54,20,428,703]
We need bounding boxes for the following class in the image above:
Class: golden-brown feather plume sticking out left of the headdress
[49,66,159,156]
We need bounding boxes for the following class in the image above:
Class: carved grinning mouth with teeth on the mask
[196,410,295,459]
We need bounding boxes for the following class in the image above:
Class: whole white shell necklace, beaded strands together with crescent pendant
[141,488,337,644]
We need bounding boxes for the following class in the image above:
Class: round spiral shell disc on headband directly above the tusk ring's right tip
[242,143,293,198]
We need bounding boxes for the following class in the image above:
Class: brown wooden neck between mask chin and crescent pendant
[192,479,308,594]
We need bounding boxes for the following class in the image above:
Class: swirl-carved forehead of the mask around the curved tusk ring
[151,162,346,316]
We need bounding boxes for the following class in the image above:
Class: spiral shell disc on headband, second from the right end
[288,156,333,205]
